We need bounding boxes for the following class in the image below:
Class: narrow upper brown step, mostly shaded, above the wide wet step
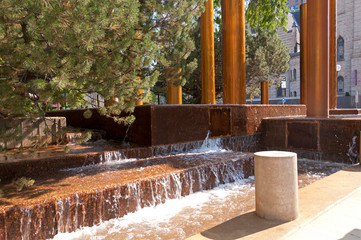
[0,134,260,183]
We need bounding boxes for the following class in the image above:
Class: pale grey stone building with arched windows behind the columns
[270,0,361,107]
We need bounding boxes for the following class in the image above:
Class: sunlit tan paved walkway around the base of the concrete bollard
[189,165,361,240]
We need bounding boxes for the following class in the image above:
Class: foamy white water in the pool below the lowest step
[54,159,348,240]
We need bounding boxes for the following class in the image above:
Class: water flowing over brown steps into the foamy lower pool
[0,132,347,240]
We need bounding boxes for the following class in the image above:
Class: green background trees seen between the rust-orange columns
[183,0,289,103]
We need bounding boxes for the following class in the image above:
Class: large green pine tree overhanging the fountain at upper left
[0,0,204,122]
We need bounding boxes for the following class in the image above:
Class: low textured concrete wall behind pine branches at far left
[0,117,66,149]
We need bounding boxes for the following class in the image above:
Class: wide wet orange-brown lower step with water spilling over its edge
[0,151,253,240]
